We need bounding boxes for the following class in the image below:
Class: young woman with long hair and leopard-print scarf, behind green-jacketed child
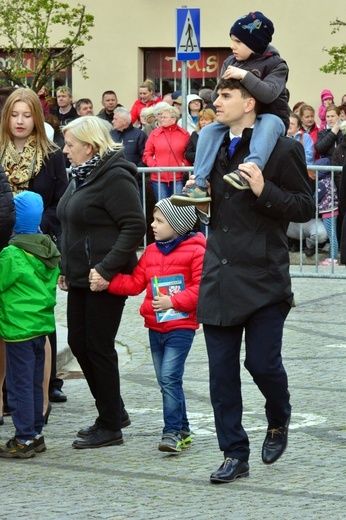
[0,88,68,414]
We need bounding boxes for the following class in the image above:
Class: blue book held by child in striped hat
[151,274,189,323]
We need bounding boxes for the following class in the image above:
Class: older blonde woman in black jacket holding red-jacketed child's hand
[58,116,146,449]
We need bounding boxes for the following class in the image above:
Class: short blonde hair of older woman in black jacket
[62,116,123,158]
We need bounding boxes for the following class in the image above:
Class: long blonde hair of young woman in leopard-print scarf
[0,88,58,157]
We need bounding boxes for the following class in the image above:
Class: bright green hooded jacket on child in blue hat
[0,234,60,342]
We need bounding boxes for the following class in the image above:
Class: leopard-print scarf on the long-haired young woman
[1,135,43,195]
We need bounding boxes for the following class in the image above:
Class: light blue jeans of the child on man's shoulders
[194,114,286,188]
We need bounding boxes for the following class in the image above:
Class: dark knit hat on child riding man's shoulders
[229,11,274,54]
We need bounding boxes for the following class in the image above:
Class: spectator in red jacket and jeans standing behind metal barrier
[142,106,191,201]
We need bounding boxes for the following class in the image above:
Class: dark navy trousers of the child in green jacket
[6,336,46,441]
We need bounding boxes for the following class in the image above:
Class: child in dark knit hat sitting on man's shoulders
[172,11,290,205]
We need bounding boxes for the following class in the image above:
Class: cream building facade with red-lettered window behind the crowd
[0,0,346,112]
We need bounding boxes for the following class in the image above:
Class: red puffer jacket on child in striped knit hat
[108,233,206,332]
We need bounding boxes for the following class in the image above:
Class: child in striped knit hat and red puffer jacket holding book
[91,198,206,453]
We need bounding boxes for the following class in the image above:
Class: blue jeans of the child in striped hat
[149,329,195,433]
